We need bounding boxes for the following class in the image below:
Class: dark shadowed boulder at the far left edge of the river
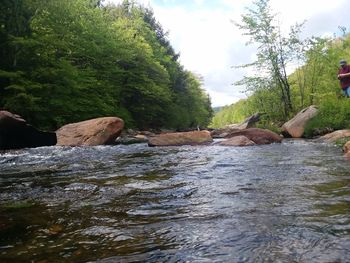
[0,111,57,150]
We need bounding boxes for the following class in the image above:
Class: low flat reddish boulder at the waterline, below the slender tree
[225,128,282,144]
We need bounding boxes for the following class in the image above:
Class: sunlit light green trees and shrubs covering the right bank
[210,0,350,136]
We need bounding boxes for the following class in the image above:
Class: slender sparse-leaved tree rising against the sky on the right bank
[235,0,303,119]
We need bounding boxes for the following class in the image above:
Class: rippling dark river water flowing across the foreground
[0,140,350,263]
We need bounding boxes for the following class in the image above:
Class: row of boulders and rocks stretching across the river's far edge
[0,109,350,157]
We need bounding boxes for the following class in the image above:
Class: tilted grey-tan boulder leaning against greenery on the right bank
[282,105,318,138]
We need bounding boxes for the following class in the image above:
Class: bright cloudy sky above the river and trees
[106,0,350,107]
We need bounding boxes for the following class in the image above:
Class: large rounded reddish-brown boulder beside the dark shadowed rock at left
[56,117,124,146]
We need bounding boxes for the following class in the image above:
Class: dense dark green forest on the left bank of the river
[0,0,212,129]
